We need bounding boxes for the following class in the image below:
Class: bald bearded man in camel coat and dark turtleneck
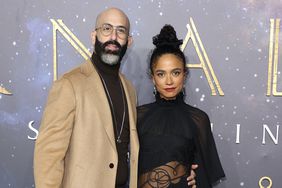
[34,8,195,188]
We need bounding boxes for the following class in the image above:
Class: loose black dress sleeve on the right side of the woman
[193,111,225,188]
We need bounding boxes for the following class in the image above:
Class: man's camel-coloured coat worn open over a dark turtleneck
[34,60,139,188]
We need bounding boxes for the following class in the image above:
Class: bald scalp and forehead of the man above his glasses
[95,8,130,31]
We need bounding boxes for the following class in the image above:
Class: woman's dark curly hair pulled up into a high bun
[149,24,188,75]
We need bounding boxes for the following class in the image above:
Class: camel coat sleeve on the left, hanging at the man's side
[34,78,75,188]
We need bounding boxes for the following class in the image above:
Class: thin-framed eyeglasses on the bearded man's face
[95,24,128,39]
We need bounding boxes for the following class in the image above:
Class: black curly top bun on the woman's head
[153,24,183,48]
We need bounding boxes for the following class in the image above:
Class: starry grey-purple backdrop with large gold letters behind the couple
[0,0,282,188]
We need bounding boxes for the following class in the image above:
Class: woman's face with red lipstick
[152,54,186,100]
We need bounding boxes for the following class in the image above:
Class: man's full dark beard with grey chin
[94,37,127,65]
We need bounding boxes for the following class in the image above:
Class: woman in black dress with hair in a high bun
[137,25,225,188]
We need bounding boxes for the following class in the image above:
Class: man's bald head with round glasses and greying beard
[91,8,132,65]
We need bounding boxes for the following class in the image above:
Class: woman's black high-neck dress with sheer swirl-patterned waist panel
[137,94,225,188]
